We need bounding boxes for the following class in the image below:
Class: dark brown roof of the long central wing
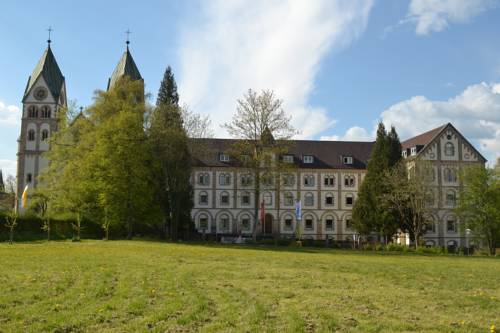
[191,139,374,169]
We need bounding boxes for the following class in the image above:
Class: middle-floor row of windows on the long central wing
[198,191,354,207]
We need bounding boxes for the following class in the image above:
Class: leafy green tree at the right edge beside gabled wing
[456,165,500,255]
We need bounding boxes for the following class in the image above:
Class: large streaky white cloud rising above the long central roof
[178,0,373,137]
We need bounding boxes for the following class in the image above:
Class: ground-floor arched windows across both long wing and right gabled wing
[195,215,458,233]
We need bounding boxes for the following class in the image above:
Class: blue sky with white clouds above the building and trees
[0,0,500,177]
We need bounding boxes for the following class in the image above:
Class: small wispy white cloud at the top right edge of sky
[402,0,497,35]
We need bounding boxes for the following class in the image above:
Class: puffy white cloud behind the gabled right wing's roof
[381,82,500,162]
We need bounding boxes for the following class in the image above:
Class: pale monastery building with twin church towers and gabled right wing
[17,43,486,246]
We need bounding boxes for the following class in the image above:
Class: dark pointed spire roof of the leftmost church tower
[23,45,64,101]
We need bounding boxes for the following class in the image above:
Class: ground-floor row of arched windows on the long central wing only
[198,215,353,232]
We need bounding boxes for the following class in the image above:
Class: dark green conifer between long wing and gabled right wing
[353,122,401,242]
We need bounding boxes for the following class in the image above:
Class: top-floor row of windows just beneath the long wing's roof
[198,172,356,187]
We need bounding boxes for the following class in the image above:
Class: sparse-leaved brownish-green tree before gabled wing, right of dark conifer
[381,159,432,248]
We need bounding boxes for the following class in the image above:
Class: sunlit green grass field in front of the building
[0,241,500,333]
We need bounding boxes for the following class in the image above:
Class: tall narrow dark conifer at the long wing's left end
[149,67,193,240]
